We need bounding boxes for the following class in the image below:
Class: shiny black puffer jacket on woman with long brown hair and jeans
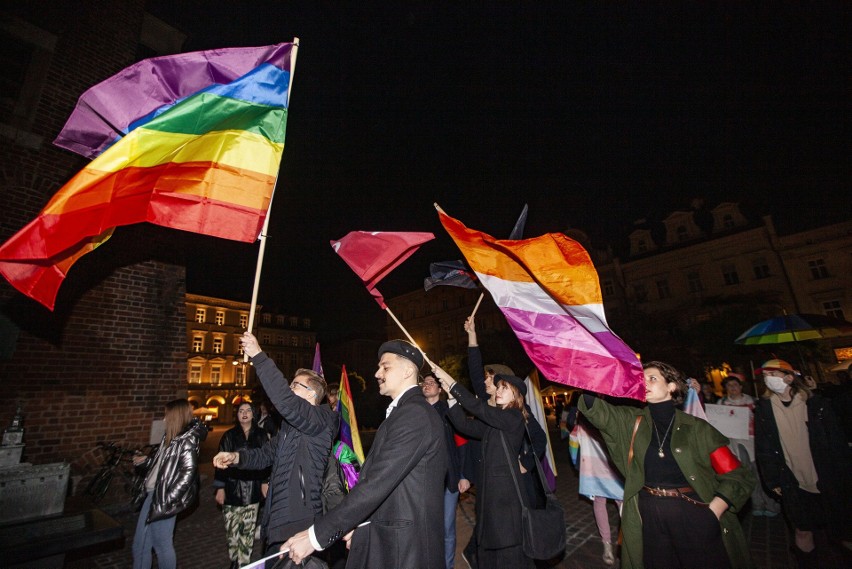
[145,419,207,523]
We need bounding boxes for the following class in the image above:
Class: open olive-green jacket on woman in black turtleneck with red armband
[579,397,755,569]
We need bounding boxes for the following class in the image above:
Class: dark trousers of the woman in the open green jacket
[639,490,731,569]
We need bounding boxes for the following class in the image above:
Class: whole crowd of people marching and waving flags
[126,316,852,569]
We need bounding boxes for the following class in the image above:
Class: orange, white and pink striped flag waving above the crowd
[438,209,645,401]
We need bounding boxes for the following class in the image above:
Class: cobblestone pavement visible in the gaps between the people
[65,418,852,569]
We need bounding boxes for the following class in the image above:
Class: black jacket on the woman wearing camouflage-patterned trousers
[213,424,269,506]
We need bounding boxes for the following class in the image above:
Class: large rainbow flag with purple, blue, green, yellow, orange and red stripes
[0,44,293,310]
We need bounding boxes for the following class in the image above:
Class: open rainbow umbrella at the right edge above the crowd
[734,314,852,346]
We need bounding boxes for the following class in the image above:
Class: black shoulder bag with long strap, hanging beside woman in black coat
[500,431,565,559]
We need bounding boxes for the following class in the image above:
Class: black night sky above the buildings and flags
[149,0,852,340]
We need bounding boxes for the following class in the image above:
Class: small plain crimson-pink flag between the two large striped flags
[331,231,435,309]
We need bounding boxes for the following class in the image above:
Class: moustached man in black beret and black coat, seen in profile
[284,340,447,569]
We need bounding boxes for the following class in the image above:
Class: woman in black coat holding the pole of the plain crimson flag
[434,366,534,569]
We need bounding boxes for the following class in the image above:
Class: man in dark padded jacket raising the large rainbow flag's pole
[213,332,340,555]
